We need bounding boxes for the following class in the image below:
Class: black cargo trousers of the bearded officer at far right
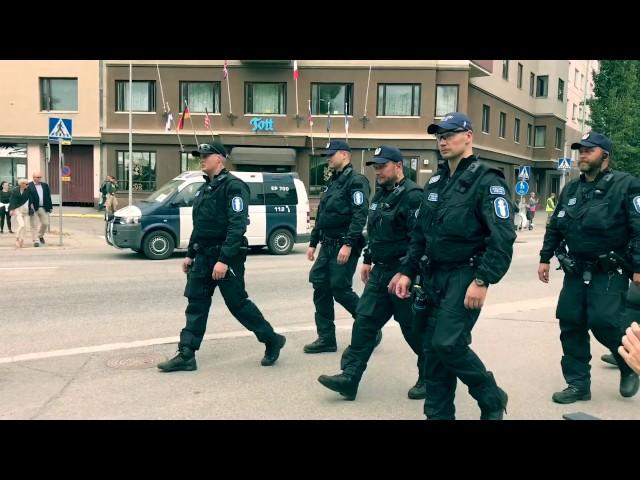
[556,271,631,390]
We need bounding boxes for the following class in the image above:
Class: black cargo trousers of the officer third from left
[343,265,424,381]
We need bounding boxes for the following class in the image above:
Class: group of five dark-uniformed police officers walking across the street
[158,112,640,419]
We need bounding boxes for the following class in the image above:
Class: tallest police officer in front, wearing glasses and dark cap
[390,112,516,420]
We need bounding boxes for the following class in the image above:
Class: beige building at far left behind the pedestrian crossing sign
[0,60,100,205]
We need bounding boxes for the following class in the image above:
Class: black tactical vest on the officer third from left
[367,179,421,262]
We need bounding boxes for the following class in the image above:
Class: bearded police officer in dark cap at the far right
[538,132,640,404]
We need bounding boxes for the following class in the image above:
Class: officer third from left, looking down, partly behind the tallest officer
[318,146,425,400]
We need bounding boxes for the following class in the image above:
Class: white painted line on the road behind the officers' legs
[0,294,558,364]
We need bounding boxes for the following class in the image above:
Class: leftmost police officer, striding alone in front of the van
[158,143,286,372]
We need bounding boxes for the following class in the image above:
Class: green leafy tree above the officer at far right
[587,60,640,176]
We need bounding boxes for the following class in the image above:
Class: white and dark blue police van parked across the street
[105,171,311,260]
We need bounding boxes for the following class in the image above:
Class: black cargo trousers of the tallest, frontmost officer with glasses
[424,266,502,419]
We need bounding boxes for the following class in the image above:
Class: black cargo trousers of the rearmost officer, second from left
[309,243,360,343]
